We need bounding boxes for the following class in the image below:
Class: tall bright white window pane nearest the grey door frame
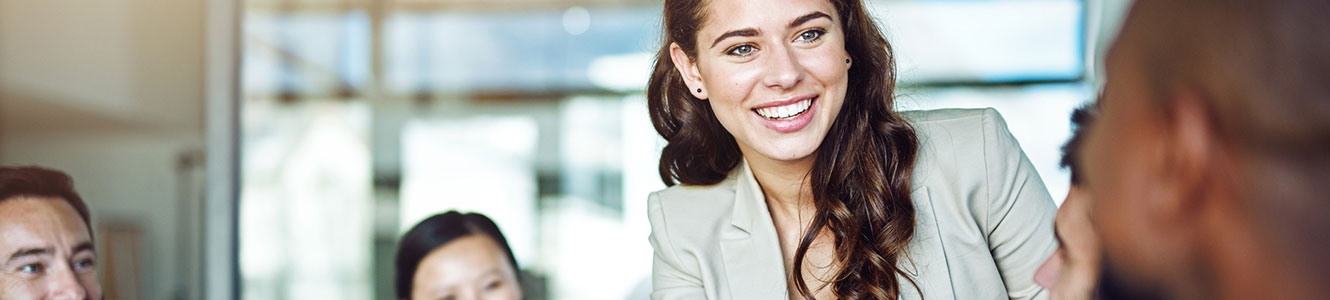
[239,101,374,299]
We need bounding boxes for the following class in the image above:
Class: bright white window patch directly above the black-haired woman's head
[399,115,539,265]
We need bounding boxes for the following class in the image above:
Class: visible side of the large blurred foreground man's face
[1080,4,1188,295]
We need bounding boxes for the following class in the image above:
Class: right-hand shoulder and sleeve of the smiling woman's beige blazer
[902,109,1056,297]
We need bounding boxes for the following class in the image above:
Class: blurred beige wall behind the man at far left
[0,0,205,299]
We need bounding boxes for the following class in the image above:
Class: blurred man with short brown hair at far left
[0,167,101,300]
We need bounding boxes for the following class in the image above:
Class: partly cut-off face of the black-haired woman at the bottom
[411,235,521,300]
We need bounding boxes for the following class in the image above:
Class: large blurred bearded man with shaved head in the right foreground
[1081,0,1330,299]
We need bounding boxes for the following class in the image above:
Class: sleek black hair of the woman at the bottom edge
[396,211,520,299]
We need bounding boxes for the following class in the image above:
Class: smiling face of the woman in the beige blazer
[670,0,850,161]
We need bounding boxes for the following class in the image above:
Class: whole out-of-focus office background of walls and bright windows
[0,0,1129,300]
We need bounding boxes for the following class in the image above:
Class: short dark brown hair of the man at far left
[0,166,92,236]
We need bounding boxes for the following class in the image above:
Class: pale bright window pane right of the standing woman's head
[870,0,1085,84]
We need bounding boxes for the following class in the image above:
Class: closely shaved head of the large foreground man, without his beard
[1096,0,1330,294]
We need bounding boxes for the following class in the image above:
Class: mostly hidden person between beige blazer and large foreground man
[1035,106,1100,300]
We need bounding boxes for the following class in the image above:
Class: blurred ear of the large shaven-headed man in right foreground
[1156,89,1224,218]
